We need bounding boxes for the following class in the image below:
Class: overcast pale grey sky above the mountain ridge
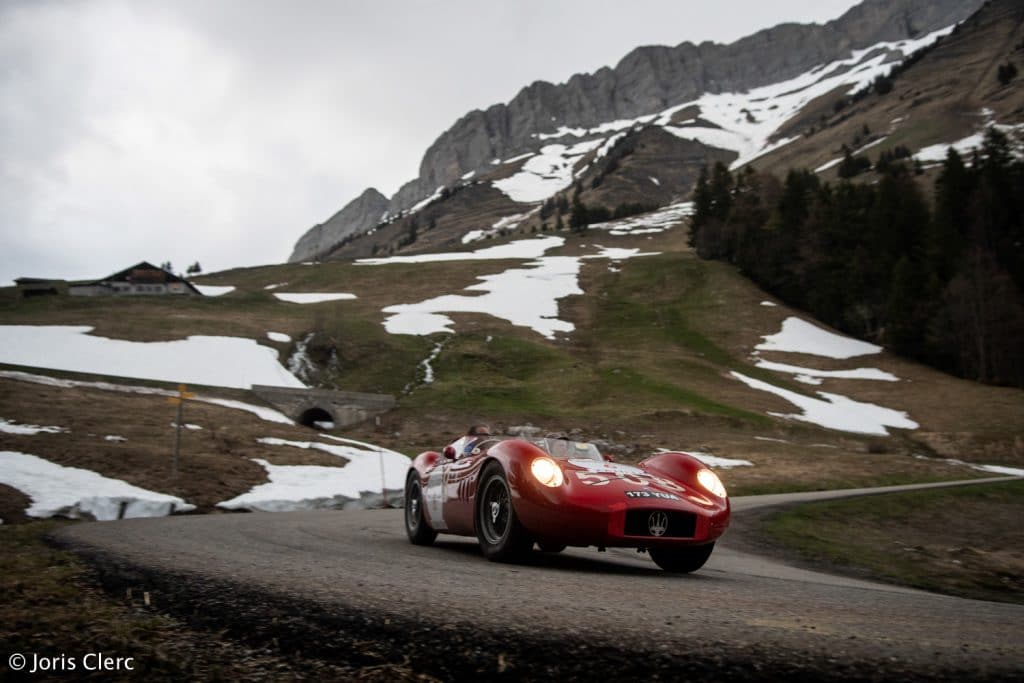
[0,0,856,286]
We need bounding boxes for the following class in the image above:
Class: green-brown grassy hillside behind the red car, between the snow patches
[0,215,1024,492]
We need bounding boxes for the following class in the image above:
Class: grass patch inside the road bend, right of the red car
[765,481,1024,603]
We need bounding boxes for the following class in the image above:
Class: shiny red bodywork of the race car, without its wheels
[412,439,730,548]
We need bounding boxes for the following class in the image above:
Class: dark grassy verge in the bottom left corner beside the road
[0,521,418,681]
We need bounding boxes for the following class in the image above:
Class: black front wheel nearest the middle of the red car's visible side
[476,463,534,562]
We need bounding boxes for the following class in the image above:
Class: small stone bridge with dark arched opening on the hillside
[252,384,395,427]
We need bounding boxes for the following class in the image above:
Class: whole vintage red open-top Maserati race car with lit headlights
[406,435,729,572]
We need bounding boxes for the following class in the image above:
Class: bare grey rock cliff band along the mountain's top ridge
[290,0,983,261]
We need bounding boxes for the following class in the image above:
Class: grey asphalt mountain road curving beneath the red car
[58,479,1024,680]
